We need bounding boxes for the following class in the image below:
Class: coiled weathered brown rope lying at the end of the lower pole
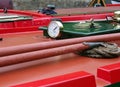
[79,42,120,58]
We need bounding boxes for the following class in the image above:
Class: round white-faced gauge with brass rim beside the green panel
[48,21,63,38]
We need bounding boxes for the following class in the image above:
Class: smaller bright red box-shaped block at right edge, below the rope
[97,62,120,83]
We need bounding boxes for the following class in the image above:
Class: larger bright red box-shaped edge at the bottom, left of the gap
[11,71,96,87]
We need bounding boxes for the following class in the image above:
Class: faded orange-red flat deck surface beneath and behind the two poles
[0,31,120,87]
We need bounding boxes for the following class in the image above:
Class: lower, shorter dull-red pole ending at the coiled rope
[0,43,89,67]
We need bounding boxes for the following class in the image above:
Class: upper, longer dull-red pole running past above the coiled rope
[0,33,120,56]
